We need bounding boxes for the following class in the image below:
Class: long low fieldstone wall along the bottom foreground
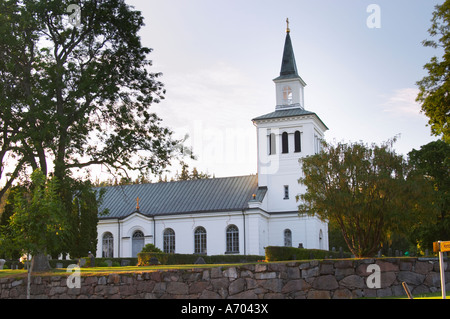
[0,258,450,299]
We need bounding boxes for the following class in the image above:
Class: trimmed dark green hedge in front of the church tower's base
[265,246,350,261]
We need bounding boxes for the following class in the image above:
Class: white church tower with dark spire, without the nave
[252,20,328,212]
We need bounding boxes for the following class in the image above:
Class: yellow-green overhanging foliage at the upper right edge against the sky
[417,0,450,143]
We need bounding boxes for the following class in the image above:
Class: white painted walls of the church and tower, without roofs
[97,28,328,257]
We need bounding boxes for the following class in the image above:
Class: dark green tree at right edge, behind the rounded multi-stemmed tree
[408,140,450,249]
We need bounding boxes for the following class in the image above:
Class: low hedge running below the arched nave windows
[138,252,265,266]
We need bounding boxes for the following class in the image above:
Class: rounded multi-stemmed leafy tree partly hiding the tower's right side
[297,141,434,257]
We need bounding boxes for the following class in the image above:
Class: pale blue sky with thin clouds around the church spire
[127,0,443,177]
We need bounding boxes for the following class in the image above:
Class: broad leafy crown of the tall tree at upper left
[0,0,183,195]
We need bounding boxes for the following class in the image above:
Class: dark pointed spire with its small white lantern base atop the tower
[273,19,306,109]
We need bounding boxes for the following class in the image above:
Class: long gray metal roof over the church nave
[99,175,265,219]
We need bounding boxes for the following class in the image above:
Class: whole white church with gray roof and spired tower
[97,22,328,258]
